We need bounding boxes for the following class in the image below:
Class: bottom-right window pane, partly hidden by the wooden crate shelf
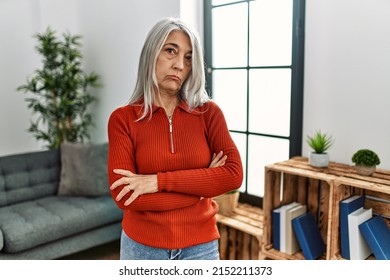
[247,135,289,197]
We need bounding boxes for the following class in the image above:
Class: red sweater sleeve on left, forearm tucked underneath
[108,107,200,211]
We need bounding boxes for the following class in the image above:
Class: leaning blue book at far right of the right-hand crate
[359,215,390,260]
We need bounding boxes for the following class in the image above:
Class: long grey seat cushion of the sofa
[0,196,122,253]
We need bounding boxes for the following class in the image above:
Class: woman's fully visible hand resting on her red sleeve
[110,169,158,206]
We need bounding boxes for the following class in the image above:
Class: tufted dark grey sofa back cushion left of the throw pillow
[0,149,60,207]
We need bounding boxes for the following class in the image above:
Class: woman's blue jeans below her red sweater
[120,231,219,260]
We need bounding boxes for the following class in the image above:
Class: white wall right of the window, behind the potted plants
[303,0,390,169]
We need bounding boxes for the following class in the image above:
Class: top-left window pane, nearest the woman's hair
[212,3,248,67]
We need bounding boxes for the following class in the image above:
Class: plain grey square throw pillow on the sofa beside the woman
[58,143,110,196]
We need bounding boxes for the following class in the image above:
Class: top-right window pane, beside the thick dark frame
[249,0,293,66]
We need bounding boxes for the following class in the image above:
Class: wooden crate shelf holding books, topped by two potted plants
[261,157,390,259]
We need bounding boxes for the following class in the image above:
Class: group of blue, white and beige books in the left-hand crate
[272,202,326,260]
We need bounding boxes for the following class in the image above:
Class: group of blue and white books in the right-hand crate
[339,195,390,260]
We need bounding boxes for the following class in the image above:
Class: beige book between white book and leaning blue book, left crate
[284,205,306,255]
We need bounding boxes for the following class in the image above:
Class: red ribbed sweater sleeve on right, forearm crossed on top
[157,102,243,197]
